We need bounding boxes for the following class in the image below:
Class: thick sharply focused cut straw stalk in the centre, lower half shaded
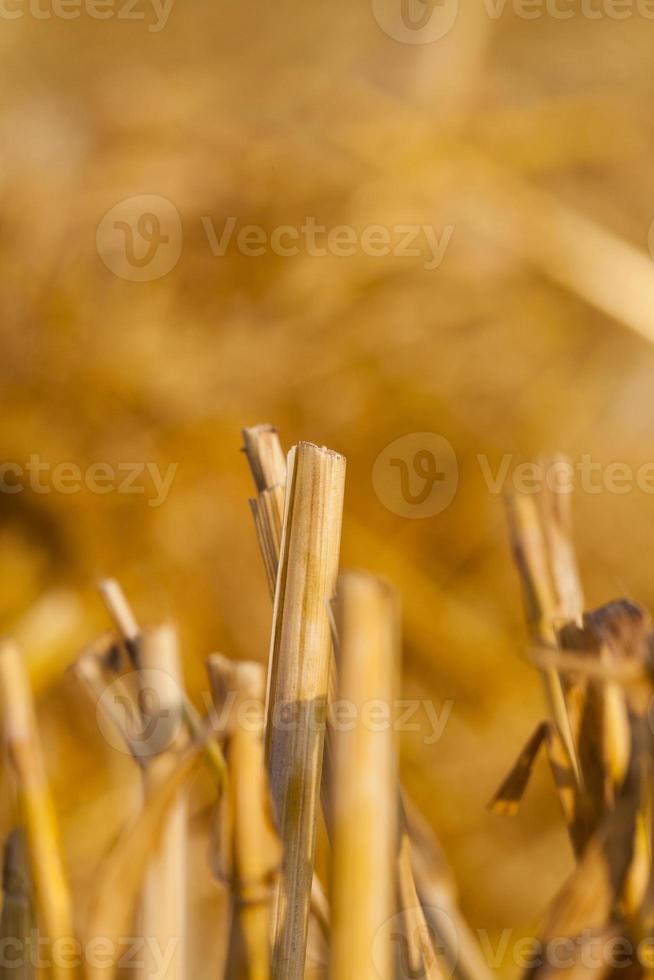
[266,443,345,980]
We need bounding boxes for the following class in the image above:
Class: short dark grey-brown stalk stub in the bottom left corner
[0,827,36,980]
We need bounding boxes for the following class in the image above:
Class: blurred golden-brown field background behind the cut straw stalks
[0,0,654,976]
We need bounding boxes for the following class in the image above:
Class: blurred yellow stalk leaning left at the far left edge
[0,638,75,980]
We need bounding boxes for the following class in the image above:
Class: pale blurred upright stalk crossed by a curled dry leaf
[138,624,187,980]
